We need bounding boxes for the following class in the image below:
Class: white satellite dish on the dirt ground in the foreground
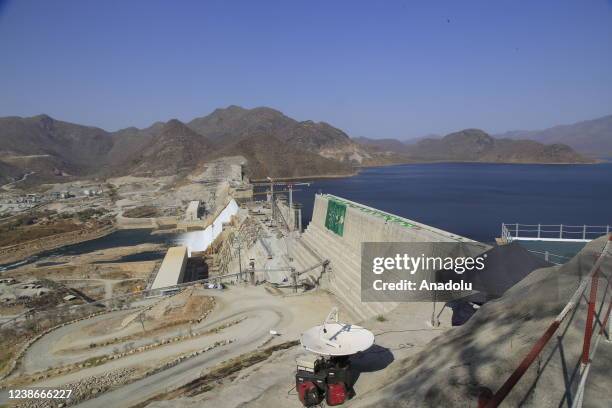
[300,307,374,356]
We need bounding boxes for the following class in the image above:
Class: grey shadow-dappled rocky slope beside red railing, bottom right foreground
[352,236,612,408]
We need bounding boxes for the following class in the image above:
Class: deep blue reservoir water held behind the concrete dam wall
[294,163,612,242]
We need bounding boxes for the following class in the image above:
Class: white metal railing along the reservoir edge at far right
[501,223,612,242]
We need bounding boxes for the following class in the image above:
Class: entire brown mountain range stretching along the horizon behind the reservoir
[0,106,604,183]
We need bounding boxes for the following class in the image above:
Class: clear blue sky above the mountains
[0,0,612,138]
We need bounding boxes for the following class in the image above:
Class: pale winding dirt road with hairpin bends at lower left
[0,287,334,407]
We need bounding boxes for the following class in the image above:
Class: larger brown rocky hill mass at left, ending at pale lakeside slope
[0,106,370,183]
